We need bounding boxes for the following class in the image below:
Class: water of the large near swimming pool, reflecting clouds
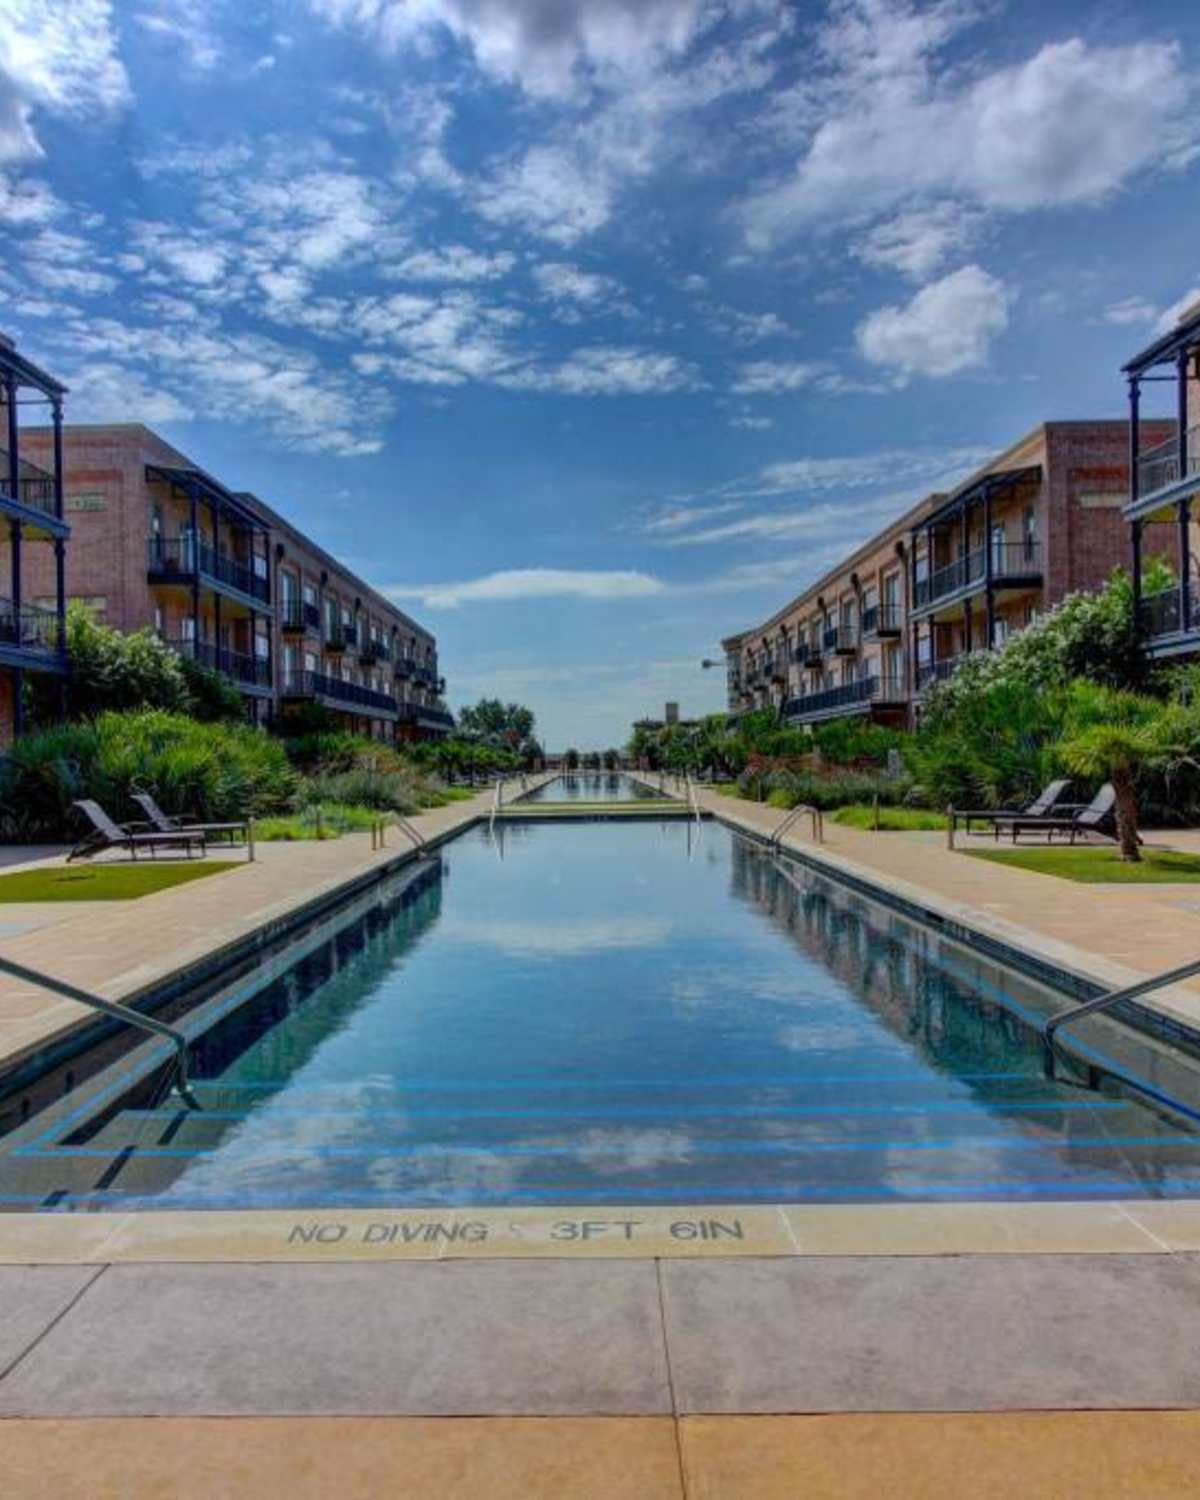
[0,819,1200,1211]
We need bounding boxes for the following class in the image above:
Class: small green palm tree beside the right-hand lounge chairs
[1058,681,1200,864]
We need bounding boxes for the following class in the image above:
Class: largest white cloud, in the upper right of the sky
[744,0,1200,248]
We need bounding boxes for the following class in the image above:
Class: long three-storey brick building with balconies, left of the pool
[18,423,453,740]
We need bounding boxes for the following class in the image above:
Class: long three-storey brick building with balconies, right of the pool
[723,422,1173,725]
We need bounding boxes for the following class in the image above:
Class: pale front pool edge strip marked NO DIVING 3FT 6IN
[0,1199,1200,1266]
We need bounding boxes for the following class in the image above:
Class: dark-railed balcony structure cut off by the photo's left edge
[0,335,71,747]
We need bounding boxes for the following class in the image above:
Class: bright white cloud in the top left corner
[0,0,129,164]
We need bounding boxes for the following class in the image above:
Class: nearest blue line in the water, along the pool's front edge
[0,1178,1200,1227]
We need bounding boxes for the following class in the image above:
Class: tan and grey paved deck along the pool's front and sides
[0,794,1200,1500]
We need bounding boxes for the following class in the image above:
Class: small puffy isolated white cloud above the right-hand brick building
[855,266,1011,377]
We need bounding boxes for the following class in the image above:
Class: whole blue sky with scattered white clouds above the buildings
[0,0,1200,747]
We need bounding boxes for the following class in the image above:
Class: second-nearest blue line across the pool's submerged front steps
[23,1136,1182,1172]
